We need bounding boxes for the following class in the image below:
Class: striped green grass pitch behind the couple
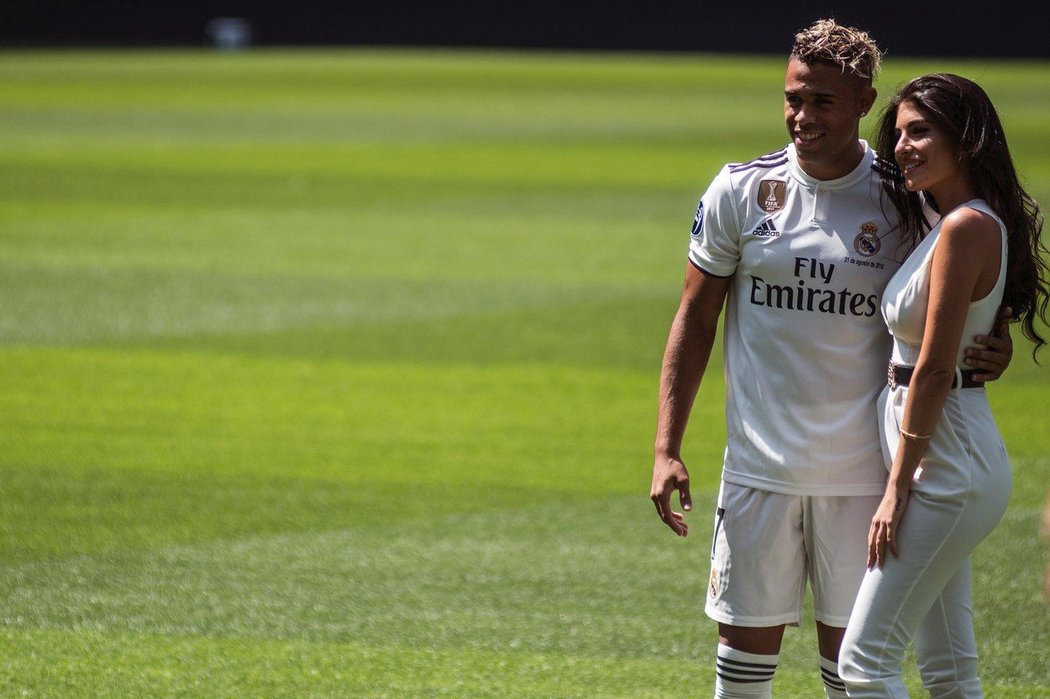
[0,49,1050,699]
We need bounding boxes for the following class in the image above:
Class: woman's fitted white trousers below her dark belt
[839,389,1010,699]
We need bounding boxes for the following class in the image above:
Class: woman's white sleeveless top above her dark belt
[882,199,1006,368]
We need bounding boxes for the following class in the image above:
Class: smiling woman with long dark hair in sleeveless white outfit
[839,73,1047,697]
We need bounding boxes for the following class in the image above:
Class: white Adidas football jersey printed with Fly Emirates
[689,143,908,495]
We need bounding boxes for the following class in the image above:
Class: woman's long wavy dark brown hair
[876,72,1048,357]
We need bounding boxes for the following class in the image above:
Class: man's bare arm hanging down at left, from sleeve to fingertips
[651,263,732,536]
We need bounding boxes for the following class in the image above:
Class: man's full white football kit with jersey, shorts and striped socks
[689,144,907,690]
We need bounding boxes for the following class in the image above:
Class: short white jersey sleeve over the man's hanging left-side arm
[689,166,740,277]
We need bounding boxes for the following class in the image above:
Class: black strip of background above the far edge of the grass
[0,0,1050,58]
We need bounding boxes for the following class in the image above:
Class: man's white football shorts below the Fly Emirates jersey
[705,481,882,628]
